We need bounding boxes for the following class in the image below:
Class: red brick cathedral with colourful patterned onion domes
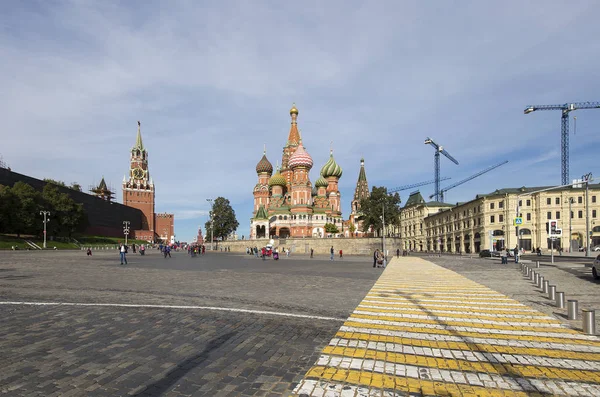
[250,105,342,239]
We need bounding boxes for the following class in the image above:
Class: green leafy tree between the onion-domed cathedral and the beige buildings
[360,186,401,232]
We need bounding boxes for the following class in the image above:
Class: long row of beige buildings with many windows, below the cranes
[408,184,600,253]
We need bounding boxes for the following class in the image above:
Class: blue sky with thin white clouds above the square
[0,0,600,241]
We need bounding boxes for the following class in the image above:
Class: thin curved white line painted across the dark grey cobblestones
[0,302,346,322]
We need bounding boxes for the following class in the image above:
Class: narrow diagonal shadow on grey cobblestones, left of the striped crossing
[134,332,236,396]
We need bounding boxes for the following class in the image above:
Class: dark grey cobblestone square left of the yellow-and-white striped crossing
[0,251,381,397]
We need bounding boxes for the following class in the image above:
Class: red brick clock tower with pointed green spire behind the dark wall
[123,121,154,233]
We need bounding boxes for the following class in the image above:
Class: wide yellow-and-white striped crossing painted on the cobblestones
[294,257,600,396]
